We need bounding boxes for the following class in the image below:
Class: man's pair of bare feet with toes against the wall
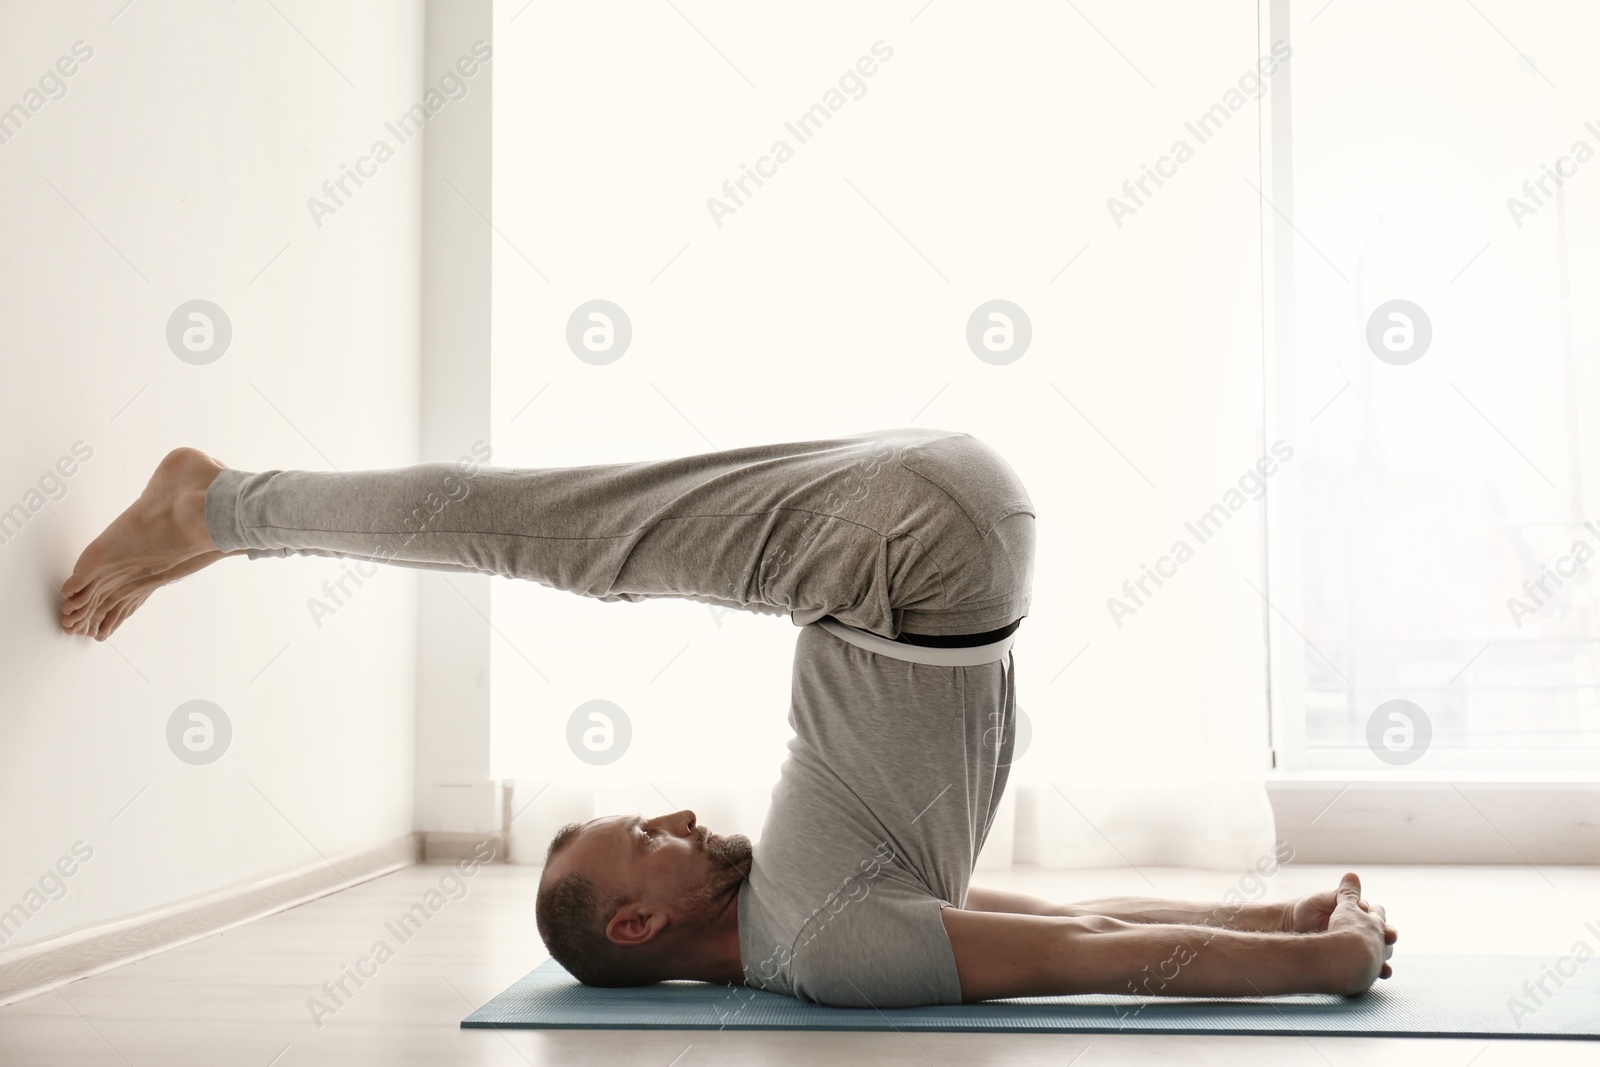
[61,448,224,640]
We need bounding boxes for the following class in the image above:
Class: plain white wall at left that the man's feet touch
[0,0,424,945]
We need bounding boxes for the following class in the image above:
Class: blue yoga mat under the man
[461,955,1600,1038]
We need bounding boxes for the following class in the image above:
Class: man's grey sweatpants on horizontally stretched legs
[206,429,1034,638]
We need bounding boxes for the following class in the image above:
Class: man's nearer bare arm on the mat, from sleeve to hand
[941,873,1394,1001]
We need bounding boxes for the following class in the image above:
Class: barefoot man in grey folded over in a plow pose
[62,429,1395,1008]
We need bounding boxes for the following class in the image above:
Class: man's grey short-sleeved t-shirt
[739,619,1016,1008]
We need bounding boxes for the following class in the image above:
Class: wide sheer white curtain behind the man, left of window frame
[491,0,1273,869]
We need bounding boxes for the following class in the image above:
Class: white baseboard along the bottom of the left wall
[0,833,421,1005]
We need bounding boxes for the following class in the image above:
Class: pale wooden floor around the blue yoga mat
[0,865,1600,1067]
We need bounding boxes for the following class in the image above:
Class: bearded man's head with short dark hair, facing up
[536,811,752,985]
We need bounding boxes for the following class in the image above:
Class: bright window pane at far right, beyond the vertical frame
[1264,0,1600,776]
